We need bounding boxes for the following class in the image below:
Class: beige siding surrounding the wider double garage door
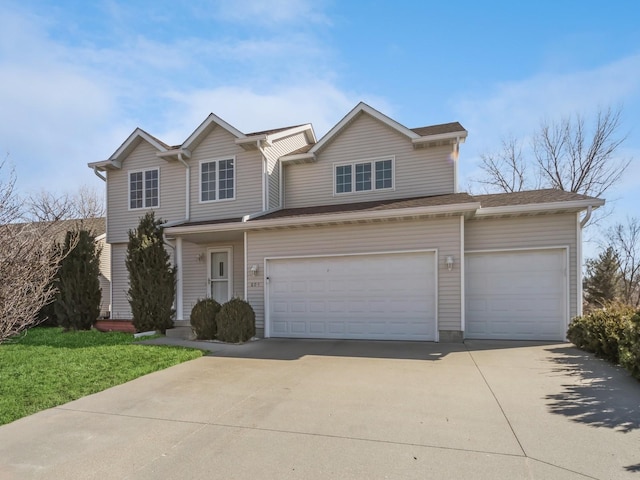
[247,217,461,331]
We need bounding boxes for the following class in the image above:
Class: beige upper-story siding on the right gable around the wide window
[285,114,455,208]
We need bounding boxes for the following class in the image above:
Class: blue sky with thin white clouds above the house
[0,0,640,244]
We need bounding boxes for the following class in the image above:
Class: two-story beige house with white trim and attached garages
[89,103,604,341]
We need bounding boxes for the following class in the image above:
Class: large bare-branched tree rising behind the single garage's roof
[478,107,631,197]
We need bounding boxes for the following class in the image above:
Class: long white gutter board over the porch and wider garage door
[166,202,480,235]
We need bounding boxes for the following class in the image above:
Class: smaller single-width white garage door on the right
[465,249,568,340]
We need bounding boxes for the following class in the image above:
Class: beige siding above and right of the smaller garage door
[465,213,578,317]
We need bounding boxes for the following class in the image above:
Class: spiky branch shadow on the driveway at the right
[546,346,640,434]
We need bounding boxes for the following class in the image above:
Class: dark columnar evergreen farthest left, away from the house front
[53,230,102,330]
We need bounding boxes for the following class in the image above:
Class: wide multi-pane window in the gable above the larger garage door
[334,158,393,194]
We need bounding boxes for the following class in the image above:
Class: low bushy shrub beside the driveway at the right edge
[567,303,635,363]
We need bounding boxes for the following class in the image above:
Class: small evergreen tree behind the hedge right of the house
[583,247,621,308]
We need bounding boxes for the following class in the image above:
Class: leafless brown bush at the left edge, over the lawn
[0,161,70,343]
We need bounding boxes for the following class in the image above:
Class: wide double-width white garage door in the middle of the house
[266,252,436,340]
